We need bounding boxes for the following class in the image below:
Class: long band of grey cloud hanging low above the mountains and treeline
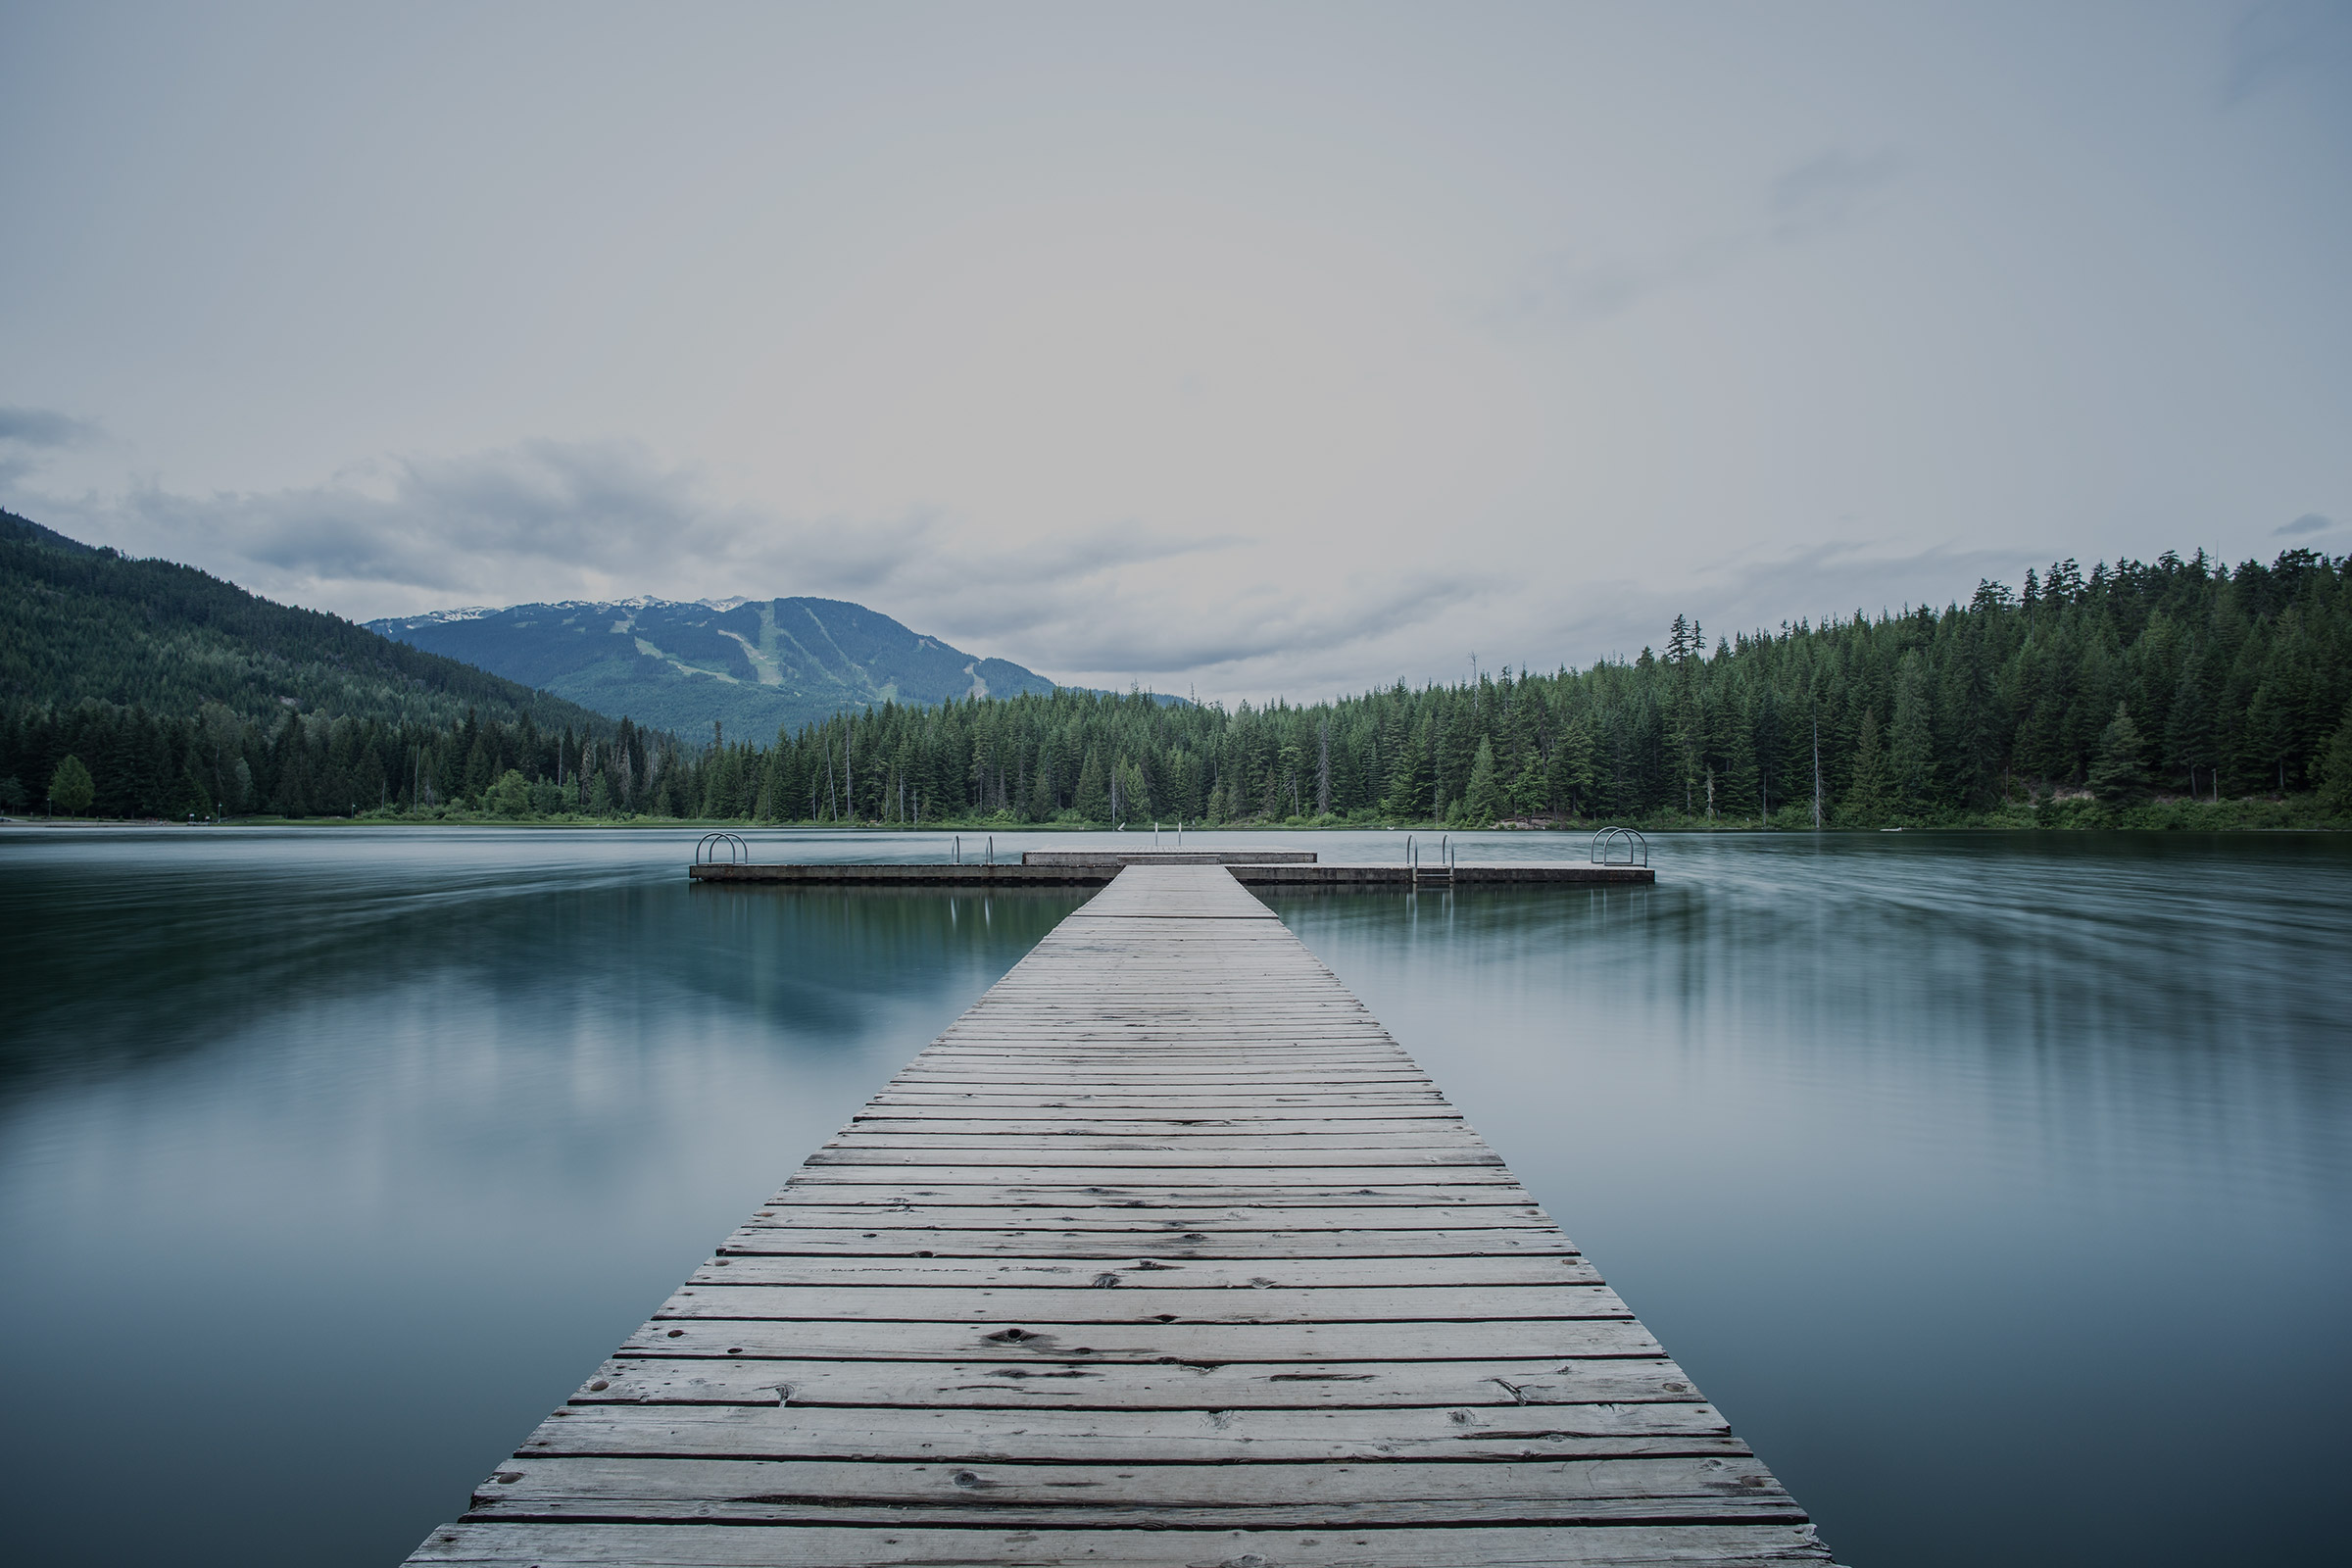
[0,425,2060,698]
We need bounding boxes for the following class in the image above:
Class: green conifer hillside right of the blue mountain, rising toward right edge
[682,550,2352,827]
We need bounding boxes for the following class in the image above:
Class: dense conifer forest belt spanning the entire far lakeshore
[0,526,2352,827]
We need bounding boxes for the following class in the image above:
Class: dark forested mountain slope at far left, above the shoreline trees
[0,511,612,733]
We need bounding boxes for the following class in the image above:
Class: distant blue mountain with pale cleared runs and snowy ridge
[367,600,1054,741]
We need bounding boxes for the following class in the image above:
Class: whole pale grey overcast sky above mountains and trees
[0,0,2352,698]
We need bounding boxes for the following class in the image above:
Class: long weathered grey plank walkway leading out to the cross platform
[410,865,1828,1568]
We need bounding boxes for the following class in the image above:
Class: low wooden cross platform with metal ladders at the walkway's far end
[689,849,1656,891]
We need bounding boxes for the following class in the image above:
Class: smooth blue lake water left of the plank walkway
[0,832,1077,1563]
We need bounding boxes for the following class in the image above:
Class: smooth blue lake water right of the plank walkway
[1277,835,2352,1563]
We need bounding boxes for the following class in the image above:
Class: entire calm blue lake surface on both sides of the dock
[0,827,2352,1568]
